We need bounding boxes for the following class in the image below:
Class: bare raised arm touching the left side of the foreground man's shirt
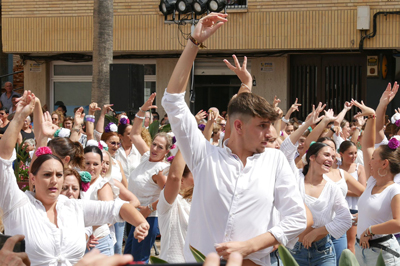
[164,150,185,204]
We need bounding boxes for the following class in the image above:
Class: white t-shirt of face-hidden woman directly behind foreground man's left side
[157,190,190,263]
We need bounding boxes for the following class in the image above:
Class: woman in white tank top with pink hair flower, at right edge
[352,90,400,266]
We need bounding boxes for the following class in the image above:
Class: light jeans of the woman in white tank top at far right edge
[356,237,400,266]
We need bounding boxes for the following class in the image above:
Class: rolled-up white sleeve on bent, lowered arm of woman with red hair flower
[79,198,129,227]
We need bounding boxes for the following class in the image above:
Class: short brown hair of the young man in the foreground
[228,93,278,122]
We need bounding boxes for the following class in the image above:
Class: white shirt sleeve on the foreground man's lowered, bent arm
[268,153,307,246]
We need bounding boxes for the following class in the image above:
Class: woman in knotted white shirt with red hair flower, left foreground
[0,91,148,266]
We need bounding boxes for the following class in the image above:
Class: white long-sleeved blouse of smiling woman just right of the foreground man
[298,170,351,239]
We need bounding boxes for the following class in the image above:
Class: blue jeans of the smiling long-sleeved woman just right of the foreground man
[289,235,336,266]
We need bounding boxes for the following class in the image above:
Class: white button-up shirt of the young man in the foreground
[162,92,306,265]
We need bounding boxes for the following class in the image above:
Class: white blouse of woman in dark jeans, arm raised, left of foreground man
[128,151,170,217]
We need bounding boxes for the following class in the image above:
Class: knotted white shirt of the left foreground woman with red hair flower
[0,151,125,266]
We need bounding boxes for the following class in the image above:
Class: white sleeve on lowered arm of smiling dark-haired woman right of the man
[325,189,351,239]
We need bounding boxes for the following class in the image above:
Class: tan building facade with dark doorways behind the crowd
[2,0,400,118]
